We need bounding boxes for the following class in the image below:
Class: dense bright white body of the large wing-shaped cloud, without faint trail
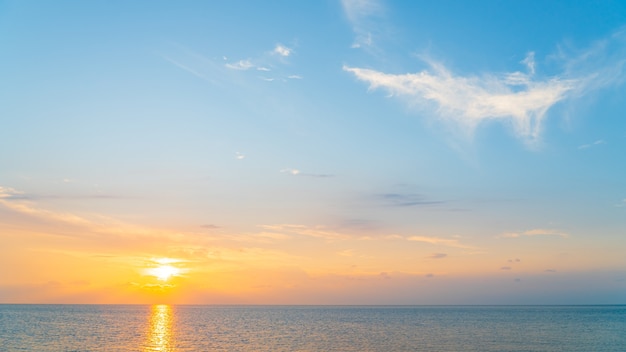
[343,57,576,142]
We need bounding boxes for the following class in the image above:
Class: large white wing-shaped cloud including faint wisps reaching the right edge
[343,28,626,146]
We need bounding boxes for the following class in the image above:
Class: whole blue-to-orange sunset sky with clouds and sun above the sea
[0,0,626,304]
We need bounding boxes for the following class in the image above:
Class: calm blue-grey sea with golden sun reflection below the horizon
[0,305,626,352]
